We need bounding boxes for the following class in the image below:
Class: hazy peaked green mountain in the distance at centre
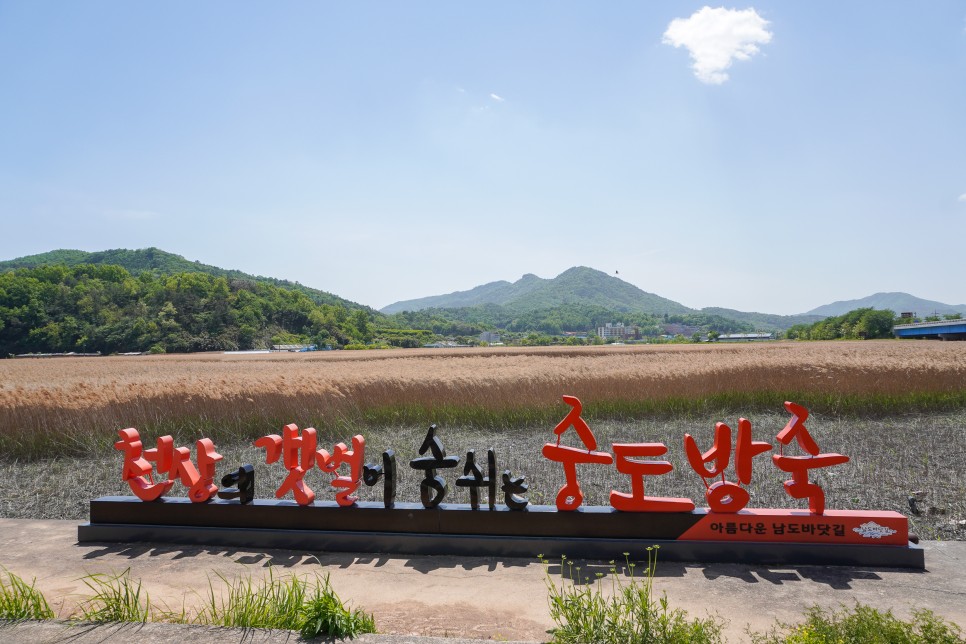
[382,266,692,315]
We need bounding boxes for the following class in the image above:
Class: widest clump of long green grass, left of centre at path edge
[196,570,376,638]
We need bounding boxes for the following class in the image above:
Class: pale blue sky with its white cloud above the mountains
[0,0,966,314]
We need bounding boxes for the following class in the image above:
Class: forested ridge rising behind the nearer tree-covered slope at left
[0,248,372,312]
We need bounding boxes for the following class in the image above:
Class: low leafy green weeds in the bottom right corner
[749,604,966,644]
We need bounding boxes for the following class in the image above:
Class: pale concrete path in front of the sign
[0,519,966,643]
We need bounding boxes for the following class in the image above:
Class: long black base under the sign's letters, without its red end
[77,497,925,569]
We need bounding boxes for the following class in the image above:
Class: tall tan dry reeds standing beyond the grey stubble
[0,341,966,451]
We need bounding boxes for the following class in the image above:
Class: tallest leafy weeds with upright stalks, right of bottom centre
[540,546,723,644]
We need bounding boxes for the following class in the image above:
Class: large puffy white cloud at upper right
[664,7,772,85]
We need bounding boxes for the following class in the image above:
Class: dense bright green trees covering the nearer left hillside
[0,264,373,355]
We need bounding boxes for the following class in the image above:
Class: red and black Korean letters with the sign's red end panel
[114,396,909,546]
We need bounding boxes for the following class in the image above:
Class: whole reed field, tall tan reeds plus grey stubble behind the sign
[0,341,966,539]
